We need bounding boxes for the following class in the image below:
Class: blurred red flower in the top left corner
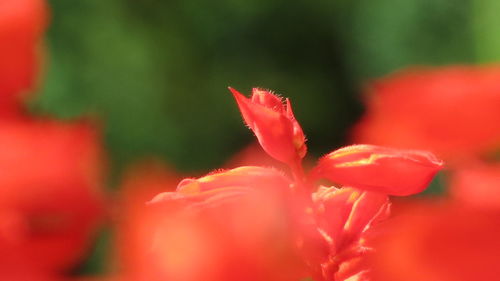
[0,0,48,115]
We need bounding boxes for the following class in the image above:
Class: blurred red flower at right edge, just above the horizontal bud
[353,66,500,161]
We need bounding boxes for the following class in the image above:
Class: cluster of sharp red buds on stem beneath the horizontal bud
[313,187,390,281]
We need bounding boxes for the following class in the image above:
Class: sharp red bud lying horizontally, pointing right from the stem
[312,145,443,196]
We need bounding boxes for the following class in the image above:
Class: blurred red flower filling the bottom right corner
[370,202,500,281]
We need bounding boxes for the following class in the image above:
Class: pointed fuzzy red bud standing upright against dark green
[229,88,307,164]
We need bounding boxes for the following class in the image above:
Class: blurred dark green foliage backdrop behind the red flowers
[31,0,500,272]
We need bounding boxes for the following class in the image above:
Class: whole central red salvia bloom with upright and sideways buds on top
[150,86,443,281]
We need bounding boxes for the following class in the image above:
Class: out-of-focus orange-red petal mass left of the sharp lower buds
[145,166,307,281]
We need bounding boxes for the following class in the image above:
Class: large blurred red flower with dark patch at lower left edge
[0,119,103,278]
